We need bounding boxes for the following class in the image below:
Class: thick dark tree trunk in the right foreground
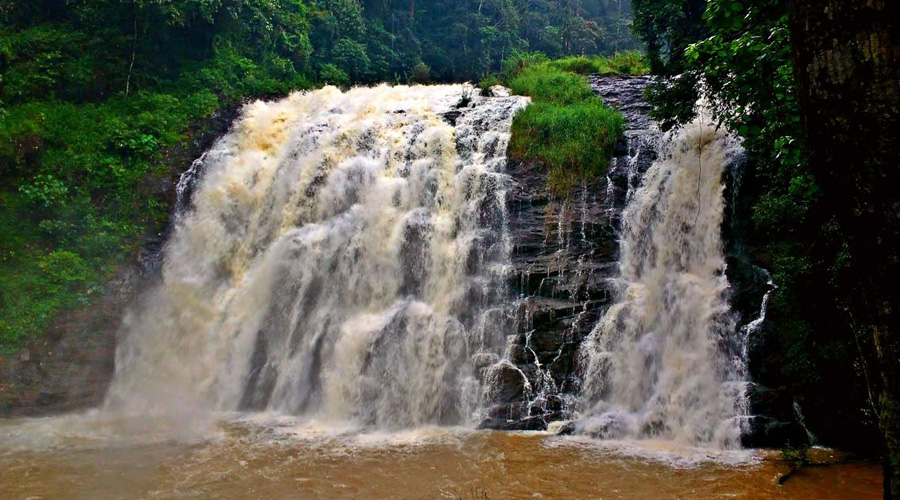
[788,0,900,500]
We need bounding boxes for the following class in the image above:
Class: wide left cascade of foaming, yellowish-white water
[105,85,527,428]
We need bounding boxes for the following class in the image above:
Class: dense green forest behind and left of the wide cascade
[0,0,637,350]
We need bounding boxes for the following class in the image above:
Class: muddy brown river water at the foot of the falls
[0,416,881,500]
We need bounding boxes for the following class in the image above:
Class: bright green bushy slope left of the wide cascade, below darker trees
[0,92,219,348]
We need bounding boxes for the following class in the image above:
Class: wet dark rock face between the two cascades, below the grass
[481,75,659,430]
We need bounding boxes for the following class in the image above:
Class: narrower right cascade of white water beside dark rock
[577,120,747,449]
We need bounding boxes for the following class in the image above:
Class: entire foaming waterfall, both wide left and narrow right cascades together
[104,85,747,448]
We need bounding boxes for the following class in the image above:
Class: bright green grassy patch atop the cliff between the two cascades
[506,54,643,193]
